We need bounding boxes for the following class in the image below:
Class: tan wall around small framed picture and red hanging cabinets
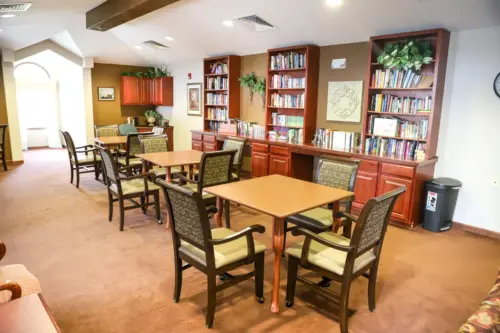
[91,64,151,125]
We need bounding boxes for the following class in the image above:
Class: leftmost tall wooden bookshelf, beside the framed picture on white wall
[203,55,241,131]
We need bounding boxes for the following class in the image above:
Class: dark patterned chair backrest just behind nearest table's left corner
[198,150,236,193]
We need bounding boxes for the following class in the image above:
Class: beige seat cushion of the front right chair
[286,231,375,275]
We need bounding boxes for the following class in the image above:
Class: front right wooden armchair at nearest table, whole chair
[285,187,406,333]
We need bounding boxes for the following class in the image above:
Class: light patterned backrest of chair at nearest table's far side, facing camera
[314,157,360,192]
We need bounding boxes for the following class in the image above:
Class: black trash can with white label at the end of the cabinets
[422,178,462,232]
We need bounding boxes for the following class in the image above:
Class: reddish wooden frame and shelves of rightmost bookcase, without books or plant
[362,29,450,160]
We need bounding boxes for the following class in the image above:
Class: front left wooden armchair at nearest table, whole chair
[157,179,266,328]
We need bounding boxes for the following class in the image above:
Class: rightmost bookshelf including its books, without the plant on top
[362,29,450,161]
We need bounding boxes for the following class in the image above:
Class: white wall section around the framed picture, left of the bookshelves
[157,60,203,150]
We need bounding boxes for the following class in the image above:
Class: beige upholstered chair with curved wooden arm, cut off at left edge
[0,241,42,304]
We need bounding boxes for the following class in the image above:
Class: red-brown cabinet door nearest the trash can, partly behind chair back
[377,175,413,223]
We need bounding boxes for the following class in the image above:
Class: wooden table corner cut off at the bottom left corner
[0,294,61,333]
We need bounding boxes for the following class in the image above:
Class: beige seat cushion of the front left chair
[179,228,266,268]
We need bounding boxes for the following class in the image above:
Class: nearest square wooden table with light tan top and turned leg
[203,175,354,313]
